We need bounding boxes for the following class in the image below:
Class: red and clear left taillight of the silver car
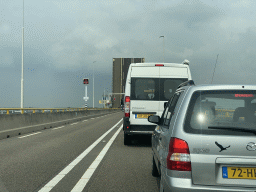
[167,137,191,171]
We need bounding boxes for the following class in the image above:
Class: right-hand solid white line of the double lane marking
[71,125,123,192]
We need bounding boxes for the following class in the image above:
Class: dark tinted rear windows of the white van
[131,78,188,101]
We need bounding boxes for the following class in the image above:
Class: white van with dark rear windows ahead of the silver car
[123,60,192,145]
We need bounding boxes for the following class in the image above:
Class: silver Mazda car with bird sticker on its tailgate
[148,81,256,192]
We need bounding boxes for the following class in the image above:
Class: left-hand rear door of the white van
[130,66,159,125]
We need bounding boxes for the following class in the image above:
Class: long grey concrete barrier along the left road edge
[0,109,120,139]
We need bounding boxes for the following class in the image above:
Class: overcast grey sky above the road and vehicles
[0,0,256,107]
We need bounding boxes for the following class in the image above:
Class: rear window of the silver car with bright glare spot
[184,90,256,135]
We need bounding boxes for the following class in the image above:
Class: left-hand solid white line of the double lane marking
[38,119,123,192]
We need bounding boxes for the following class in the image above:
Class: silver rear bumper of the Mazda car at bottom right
[162,168,256,192]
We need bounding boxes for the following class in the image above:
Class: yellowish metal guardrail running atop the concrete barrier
[0,108,118,115]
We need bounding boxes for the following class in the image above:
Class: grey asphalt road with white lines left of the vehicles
[0,112,159,192]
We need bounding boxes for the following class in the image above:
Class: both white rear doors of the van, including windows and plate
[130,66,189,125]
